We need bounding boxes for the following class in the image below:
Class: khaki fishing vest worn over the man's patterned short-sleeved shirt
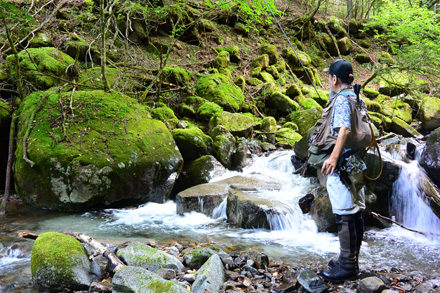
[310,91,373,151]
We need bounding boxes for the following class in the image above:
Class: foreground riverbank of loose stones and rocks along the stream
[32,233,440,293]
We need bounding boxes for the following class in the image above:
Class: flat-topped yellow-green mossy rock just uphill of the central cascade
[209,111,254,137]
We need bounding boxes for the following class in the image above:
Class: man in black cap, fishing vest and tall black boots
[309,59,371,281]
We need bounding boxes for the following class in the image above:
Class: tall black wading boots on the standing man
[321,215,359,282]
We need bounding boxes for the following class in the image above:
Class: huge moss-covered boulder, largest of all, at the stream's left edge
[14,91,182,210]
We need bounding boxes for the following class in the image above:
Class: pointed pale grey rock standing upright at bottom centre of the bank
[191,254,225,293]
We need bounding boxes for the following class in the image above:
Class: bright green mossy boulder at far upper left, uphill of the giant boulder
[6,47,75,89]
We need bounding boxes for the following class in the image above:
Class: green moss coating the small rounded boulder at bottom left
[31,232,88,287]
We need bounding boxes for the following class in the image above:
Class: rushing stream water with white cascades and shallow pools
[0,151,440,292]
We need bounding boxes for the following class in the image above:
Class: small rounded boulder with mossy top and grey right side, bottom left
[31,232,93,291]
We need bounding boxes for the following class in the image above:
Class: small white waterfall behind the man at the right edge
[391,157,440,235]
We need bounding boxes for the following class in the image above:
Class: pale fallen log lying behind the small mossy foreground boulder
[18,231,125,273]
